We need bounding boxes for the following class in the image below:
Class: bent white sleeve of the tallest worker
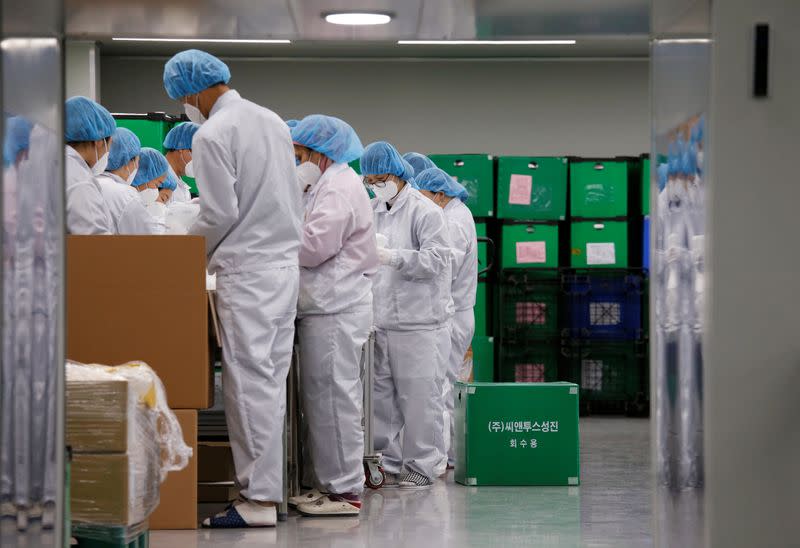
[189,136,239,256]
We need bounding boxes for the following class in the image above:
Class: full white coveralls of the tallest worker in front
[189,90,301,502]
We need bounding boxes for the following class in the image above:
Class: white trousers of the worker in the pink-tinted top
[297,302,372,494]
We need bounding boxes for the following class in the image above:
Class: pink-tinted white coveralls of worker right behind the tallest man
[298,163,378,494]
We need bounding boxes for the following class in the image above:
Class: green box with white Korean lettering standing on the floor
[455,382,580,485]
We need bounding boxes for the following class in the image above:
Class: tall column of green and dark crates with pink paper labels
[495,156,569,383]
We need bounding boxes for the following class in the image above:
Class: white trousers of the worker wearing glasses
[372,327,450,478]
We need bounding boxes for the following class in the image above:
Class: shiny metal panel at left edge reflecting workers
[0,34,64,546]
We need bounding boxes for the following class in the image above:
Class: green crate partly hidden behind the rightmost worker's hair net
[429,154,494,218]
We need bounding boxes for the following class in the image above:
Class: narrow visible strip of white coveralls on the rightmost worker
[444,198,478,464]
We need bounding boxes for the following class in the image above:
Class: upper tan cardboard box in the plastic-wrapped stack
[66,380,135,453]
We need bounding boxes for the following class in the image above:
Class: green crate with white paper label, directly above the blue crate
[572,221,628,268]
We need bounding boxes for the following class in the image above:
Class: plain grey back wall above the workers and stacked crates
[101,57,649,156]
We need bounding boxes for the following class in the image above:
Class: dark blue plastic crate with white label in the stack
[564,271,644,340]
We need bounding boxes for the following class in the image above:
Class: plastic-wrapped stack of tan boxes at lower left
[67,362,191,540]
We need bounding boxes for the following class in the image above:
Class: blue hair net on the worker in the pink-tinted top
[292,114,364,164]
